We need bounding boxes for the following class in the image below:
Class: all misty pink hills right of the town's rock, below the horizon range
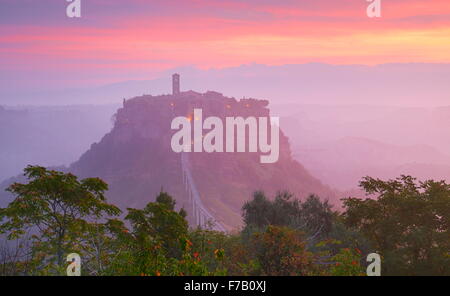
[272,104,450,191]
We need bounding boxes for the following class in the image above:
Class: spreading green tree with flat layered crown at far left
[0,166,120,268]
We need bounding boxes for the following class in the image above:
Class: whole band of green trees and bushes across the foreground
[0,166,450,276]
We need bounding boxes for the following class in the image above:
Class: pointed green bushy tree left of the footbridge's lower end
[106,192,226,276]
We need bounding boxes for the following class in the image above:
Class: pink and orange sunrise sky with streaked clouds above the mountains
[0,0,450,91]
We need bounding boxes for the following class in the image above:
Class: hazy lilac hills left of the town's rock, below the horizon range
[0,105,118,182]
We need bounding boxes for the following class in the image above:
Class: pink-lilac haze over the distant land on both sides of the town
[0,64,450,199]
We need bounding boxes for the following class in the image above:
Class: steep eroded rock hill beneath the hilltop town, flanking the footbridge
[70,91,334,229]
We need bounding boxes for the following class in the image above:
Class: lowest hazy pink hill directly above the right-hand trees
[294,137,450,190]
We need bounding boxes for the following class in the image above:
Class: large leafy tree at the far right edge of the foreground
[343,176,450,275]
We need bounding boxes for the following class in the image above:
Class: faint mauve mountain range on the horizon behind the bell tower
[4,63,450,106]
